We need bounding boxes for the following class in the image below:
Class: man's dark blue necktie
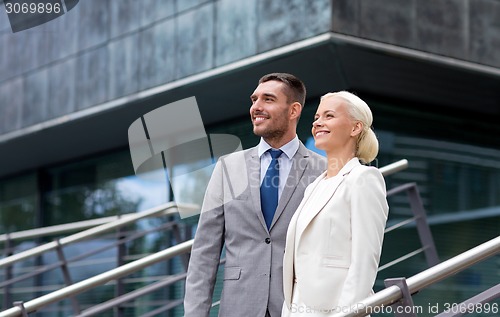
[260,149,283,229]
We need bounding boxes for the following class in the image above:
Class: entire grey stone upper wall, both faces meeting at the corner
[0,0,500,134]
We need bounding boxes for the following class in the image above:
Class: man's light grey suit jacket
[184,143,326,317]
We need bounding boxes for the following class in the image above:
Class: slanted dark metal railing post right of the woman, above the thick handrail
[407,184,439,267]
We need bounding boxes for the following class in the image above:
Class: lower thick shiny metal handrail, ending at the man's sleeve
[0,240,193,317]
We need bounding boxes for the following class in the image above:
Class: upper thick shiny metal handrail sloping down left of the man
[0,202,198,268]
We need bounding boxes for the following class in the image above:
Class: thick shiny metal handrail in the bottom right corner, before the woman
[334,236,500,317]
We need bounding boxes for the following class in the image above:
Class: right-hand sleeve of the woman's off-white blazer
[339,167,389,308]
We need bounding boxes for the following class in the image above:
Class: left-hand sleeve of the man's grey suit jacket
[184,161,224,317]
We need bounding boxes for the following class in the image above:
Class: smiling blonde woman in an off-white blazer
[282,91,388,317]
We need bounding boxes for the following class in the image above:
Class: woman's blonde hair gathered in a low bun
[321,91,378,163]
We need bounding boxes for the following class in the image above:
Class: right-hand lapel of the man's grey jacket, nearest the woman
[269,143,309,230]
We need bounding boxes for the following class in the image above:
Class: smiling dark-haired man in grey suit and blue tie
[184,73,326,317]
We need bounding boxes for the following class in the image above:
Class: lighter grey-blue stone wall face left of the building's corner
[0,0,331,134]
